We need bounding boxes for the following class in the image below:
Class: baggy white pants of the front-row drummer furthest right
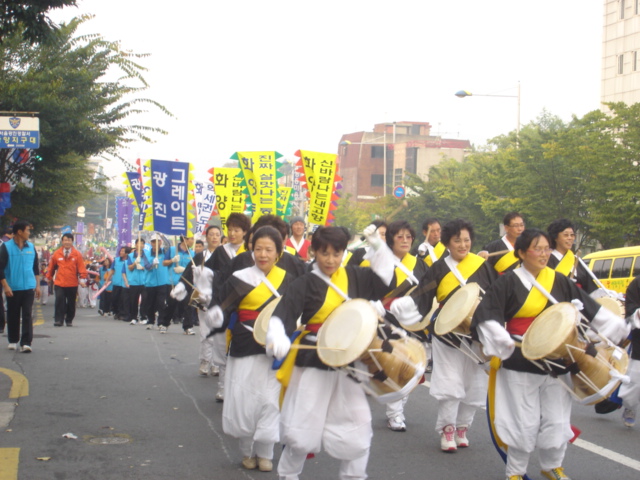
[495,368,573,476]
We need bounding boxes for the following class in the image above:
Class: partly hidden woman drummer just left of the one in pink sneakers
[378,220,427,432]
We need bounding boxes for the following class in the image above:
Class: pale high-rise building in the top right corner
[600,0,640,105]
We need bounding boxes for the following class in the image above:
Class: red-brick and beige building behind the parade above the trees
[338,122,471,200]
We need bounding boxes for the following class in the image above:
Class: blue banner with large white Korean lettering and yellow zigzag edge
[143,160,193,235]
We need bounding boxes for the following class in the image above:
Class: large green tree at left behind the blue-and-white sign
[0,16,171,231]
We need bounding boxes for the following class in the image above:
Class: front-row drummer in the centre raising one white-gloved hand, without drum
[267,225,393,480]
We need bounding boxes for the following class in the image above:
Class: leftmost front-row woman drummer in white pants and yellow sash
[212,226,295,472]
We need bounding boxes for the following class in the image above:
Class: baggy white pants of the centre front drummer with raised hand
[278,367,373,480]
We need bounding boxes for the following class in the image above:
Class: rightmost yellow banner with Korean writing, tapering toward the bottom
[296,150,340,225]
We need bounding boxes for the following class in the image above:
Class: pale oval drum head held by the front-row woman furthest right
[522,302,578,360]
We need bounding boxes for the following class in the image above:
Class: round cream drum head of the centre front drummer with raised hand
[318,299,378,367]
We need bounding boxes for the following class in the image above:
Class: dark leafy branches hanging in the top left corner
[0,0,76,44]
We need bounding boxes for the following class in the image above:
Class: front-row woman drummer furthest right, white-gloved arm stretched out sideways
[472,229,629,480]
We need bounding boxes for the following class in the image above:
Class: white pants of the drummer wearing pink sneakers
[429,339,489,433]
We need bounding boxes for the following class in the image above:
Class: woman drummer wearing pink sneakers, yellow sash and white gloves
[391,219,497,452]
